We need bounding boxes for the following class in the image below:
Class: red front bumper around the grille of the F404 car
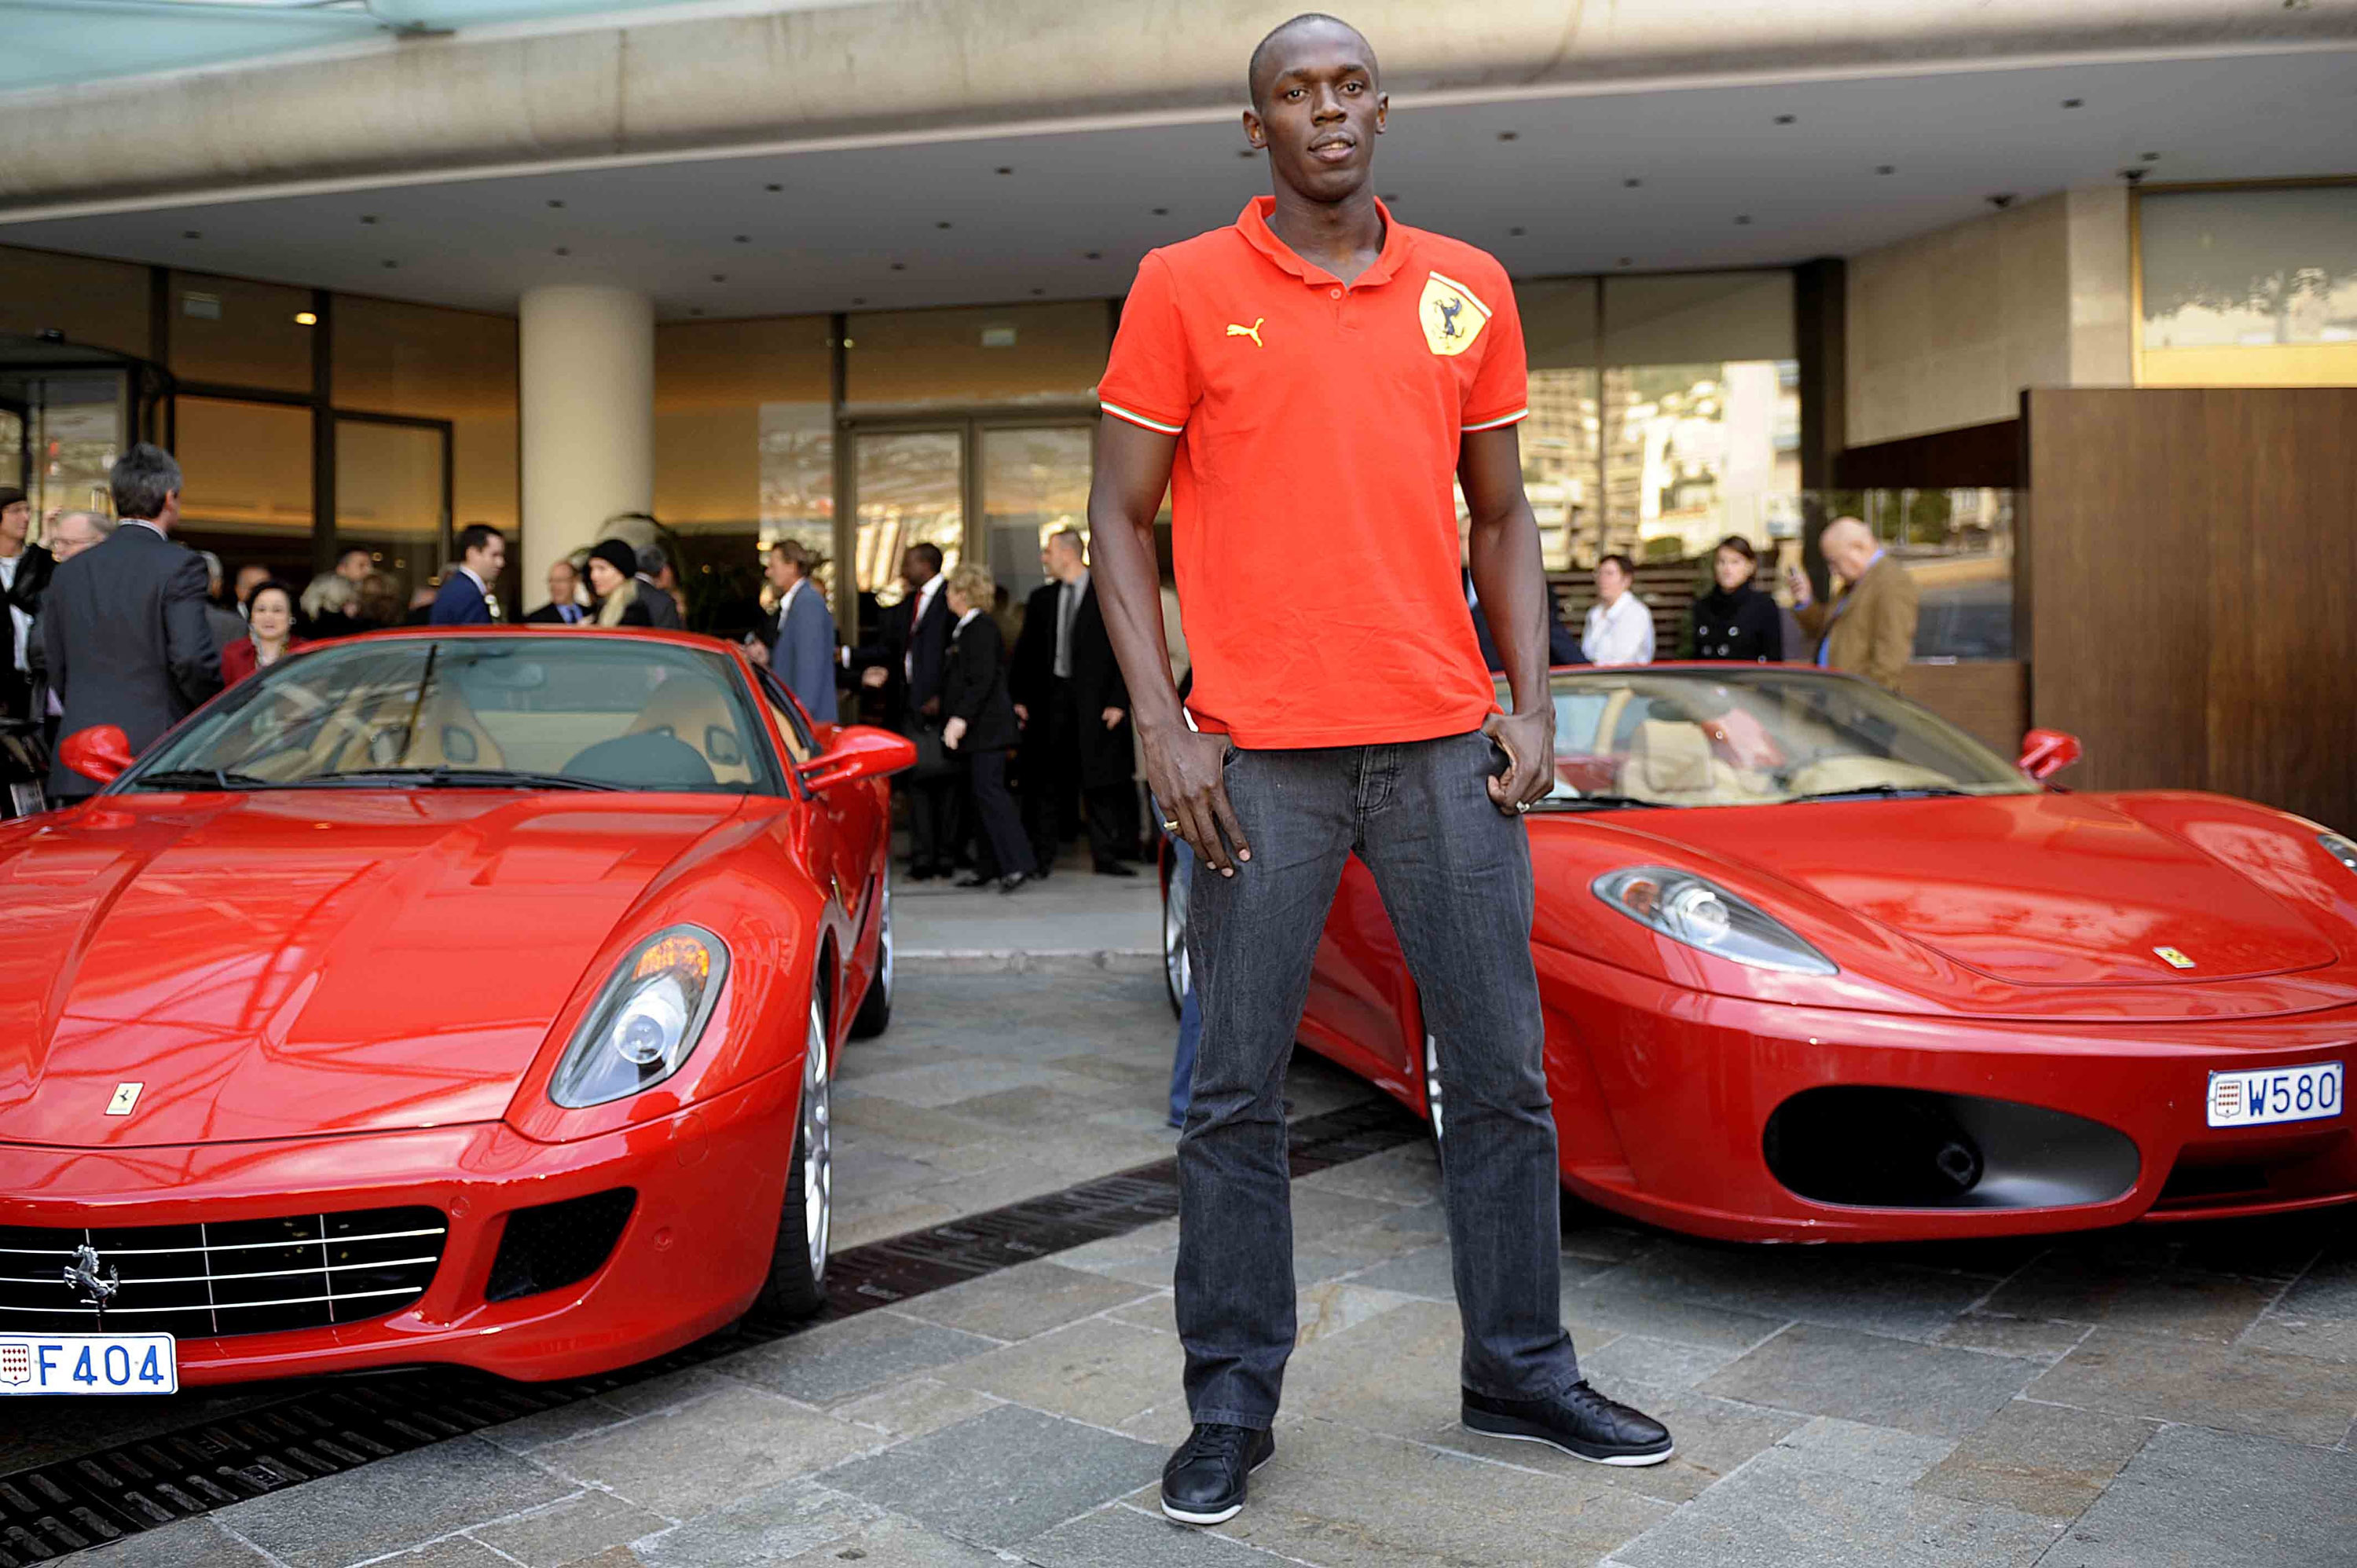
[0,1071,799,1384]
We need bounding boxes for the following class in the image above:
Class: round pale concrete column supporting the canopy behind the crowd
[519,283,655,589]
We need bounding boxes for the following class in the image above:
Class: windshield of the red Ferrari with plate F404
[120,632,780,795]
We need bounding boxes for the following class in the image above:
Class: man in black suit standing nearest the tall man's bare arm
[1009,528,1136,877]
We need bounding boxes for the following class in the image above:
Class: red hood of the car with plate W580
[1640,793,2338,986]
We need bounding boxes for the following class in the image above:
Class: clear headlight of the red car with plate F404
[549,927,728,1108]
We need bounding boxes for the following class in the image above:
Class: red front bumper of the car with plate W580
[1534,948,2357,1240]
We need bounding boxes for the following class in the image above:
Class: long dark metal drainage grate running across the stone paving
[0,1101,1424,1568]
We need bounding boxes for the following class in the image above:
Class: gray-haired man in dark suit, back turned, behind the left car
[40,441,222,802]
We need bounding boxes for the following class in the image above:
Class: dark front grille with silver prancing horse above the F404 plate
[0,1207,448,1339]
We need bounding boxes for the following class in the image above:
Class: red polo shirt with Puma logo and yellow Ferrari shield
[1098,196,1527,747]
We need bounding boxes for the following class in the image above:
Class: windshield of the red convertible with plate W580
[1501,665,2036,811]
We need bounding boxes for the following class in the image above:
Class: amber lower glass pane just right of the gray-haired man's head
[172,396,311,589]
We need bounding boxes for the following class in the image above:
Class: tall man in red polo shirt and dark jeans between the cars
[1089,16,1671,1523]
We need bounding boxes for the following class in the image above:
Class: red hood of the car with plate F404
[0,790,742,1149]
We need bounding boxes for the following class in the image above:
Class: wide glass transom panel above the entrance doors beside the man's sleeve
[844,299,1113,410]
